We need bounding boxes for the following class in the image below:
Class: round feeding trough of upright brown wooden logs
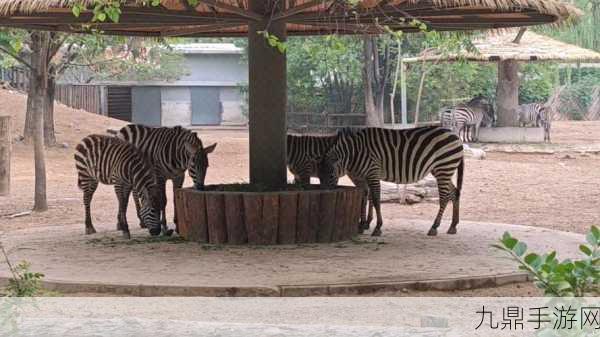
[175,187,362,245]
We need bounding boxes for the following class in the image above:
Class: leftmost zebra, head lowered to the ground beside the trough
[75,135,163,239]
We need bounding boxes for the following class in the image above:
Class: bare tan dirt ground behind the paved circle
[0,90,600,295]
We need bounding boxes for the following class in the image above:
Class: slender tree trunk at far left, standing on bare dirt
[29,32,50,212]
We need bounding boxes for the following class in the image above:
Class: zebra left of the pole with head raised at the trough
[117,124,217,232]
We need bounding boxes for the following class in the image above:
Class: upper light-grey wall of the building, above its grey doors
[181,54,248,83]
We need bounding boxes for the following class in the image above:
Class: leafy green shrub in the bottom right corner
[493,226,600,297]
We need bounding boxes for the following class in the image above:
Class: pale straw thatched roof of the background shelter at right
[404,30,600,63]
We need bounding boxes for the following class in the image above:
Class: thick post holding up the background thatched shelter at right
[496,60,519,126]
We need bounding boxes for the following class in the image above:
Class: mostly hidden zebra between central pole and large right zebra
[287,134,373,227]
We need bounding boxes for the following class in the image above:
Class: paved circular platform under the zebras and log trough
[0,219,584,296]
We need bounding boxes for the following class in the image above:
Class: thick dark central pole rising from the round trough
[248,0,287,188]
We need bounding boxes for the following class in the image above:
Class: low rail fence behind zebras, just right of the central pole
[287,112,367,133]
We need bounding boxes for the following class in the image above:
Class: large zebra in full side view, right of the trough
[319,127,464,236]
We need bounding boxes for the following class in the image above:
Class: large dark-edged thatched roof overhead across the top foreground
[0,0,580,36]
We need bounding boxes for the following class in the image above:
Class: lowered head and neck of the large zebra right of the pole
[319,128,353,189]
